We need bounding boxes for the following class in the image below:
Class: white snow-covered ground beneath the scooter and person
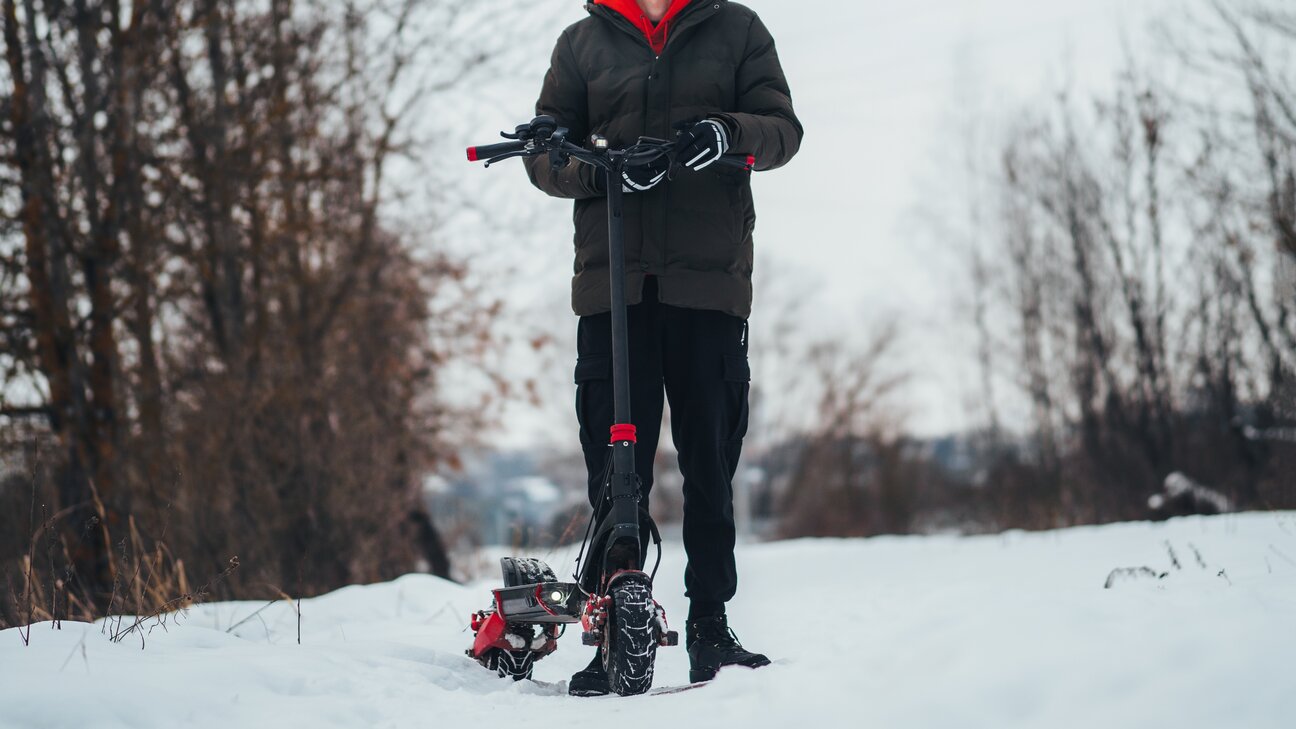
[0,512,1296,729]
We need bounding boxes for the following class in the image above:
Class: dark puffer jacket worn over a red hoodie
[527,0,802,319]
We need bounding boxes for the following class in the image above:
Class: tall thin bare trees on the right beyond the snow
[948,3,1296,525]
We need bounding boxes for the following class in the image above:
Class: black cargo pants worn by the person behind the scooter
[575,276,752,617]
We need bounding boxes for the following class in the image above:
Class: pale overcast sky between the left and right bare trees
[427,0,1173,445]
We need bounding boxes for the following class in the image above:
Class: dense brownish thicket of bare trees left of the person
[0,0,505,625]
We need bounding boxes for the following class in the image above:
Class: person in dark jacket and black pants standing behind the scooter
[527,0,802,695]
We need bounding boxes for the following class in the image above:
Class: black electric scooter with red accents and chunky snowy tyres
[468,117,756,695]
